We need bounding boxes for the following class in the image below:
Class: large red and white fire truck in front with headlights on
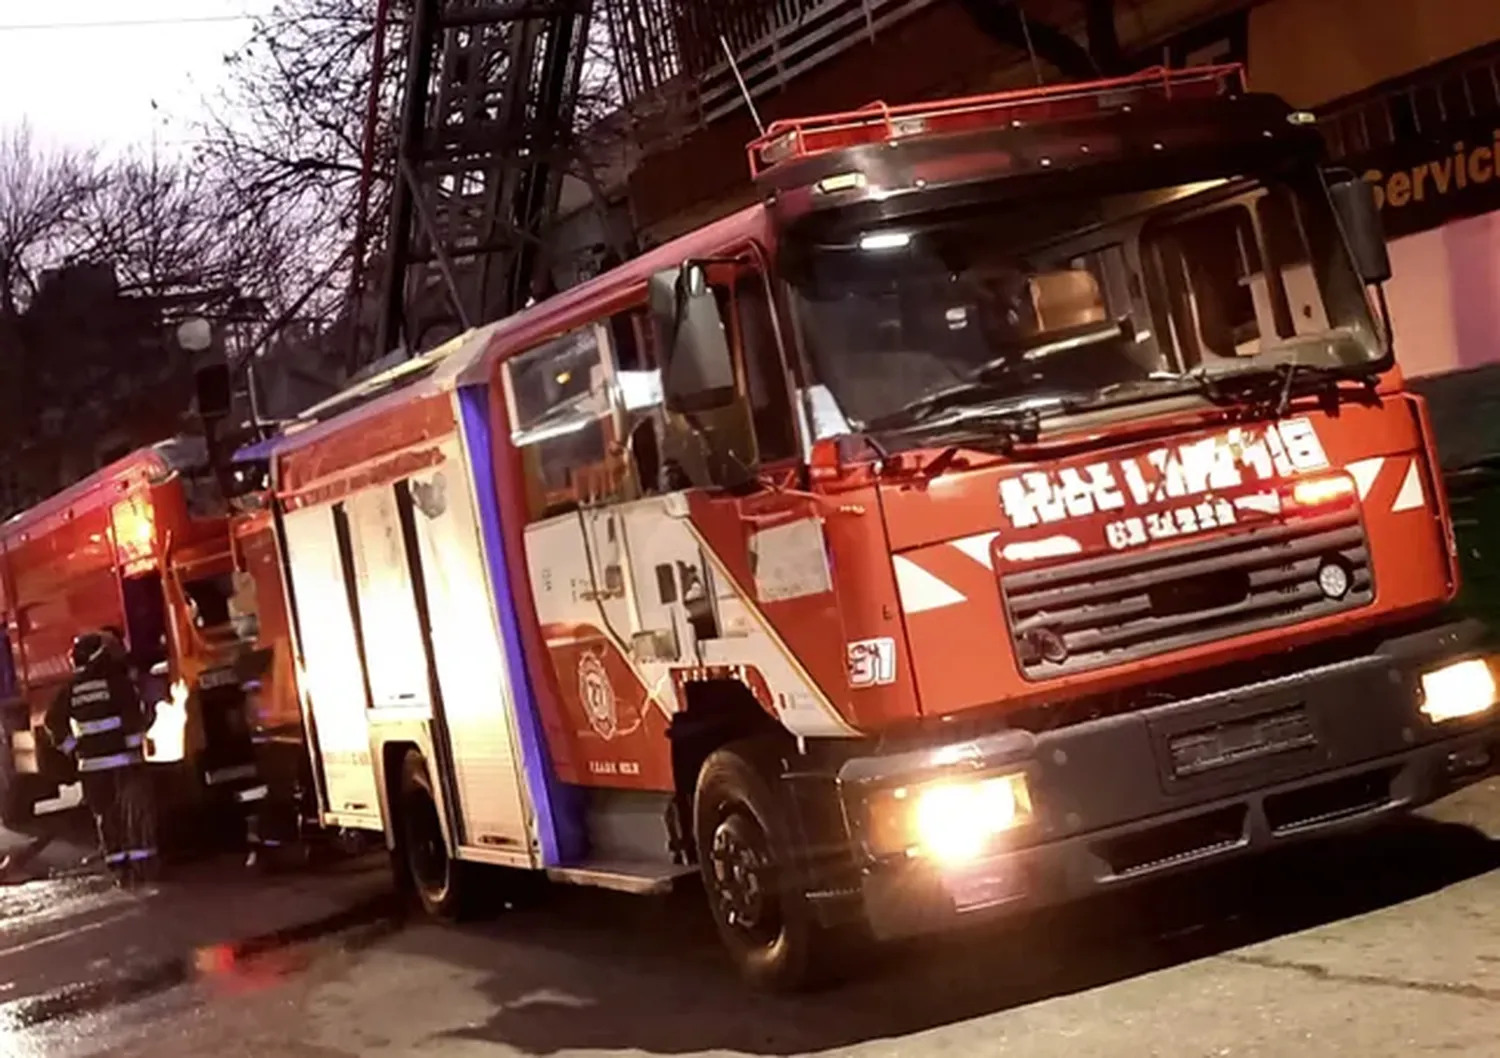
[257,68,1497,986]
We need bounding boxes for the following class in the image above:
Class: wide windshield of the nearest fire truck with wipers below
[783,174,1380,429]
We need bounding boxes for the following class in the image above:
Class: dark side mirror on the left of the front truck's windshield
[650,261,735,411]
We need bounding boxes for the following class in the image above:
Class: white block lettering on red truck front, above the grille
[999,419,1329,549]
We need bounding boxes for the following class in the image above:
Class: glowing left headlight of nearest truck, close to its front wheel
[870,773,1032,864]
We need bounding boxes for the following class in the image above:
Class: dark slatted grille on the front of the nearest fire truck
[1001,510,1374,680]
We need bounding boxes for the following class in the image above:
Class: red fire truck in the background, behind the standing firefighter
[0,438,300,833]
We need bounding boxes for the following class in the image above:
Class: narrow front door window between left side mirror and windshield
[714,270,798,462]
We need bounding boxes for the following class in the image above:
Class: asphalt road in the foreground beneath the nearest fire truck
[0,782,1500,1058]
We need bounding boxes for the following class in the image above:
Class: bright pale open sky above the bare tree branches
[0,0,275,153]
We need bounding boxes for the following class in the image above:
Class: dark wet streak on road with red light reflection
[0,896,401,1038]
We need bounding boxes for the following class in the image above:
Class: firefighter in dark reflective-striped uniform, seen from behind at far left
[47,632,158,884]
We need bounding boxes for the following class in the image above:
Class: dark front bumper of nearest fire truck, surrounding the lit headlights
[839,623,1500,938]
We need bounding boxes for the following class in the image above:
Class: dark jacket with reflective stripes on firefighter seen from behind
[47,656,149,776]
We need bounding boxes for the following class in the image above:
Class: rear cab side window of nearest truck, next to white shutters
[506,324,624,521]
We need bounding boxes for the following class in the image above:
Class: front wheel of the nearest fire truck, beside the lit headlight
[693,744,854,992]
